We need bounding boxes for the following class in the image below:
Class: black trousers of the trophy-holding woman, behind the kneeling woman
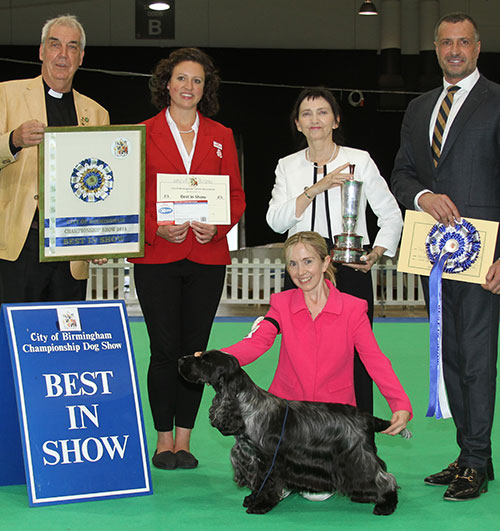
[285,256,373,414]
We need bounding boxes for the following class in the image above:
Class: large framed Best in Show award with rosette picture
[39,125,146,262]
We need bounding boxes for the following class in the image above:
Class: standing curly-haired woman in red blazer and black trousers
[131,48,245,470]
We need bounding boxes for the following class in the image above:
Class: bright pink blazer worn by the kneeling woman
[222,280,412,413]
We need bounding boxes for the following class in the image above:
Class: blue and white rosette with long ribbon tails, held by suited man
[425,219,481,419]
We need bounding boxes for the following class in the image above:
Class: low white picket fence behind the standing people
[87,258,425,308]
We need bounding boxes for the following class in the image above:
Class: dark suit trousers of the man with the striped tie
[422,277,499,472]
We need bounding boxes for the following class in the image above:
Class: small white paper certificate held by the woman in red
[156,173,231,225]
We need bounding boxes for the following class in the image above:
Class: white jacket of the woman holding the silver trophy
[266,146,403,256]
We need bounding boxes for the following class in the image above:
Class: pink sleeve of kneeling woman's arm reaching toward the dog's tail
[354,311,413,416]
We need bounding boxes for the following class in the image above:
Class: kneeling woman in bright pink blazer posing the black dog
[222,231,412,428]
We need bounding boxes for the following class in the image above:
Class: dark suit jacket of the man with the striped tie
[391,76,500,256]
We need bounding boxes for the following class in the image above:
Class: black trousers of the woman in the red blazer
[134,260,226,431]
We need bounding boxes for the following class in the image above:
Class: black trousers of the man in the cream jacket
[0,229,87,304]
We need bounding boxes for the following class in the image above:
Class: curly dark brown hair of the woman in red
[149,48,220,116]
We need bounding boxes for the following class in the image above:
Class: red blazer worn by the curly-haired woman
[130,109,245,264]
